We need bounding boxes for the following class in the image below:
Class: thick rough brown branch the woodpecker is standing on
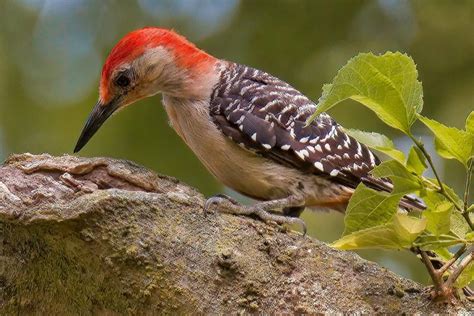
[0,154,474,315]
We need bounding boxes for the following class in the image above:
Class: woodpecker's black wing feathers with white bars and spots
[210,64,384,191]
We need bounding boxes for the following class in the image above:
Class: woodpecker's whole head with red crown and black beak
[74,27,216,152]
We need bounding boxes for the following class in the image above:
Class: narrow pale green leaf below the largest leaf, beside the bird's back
[344,129,405,162]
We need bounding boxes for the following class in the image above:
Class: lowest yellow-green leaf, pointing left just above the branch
[332,214,426,250]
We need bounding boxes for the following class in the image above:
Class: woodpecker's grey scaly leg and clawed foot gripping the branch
[204,195,306,235]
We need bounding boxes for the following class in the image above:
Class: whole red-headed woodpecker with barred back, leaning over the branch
[74,27,423,235]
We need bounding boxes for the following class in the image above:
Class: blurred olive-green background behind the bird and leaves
[0,0,474,283]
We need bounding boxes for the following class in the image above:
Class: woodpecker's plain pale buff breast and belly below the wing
[164,97,352,206]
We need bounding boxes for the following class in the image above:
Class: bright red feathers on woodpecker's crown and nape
[100,27,214,102]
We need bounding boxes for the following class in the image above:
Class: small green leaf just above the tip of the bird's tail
[370,160,422,194]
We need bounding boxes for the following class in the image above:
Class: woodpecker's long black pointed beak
[74,100,119,153]
